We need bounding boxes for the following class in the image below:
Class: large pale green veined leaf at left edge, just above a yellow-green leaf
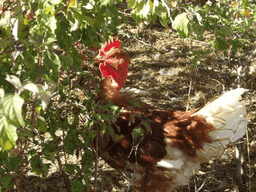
[1,95,25,127]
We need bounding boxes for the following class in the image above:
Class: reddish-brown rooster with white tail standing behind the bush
[95,38,247,192]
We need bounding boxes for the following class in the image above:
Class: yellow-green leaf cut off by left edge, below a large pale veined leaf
[0,115,18,151]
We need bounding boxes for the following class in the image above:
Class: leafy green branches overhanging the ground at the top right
[129,0,256,68]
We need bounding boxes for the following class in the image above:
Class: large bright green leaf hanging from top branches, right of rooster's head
[172,13,189,38]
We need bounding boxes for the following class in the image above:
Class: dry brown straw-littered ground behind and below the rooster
[18,16,256,192]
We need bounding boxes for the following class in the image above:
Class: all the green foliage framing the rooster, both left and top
[0,0,256,191]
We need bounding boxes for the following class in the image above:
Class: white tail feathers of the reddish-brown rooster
[193,88,247,160]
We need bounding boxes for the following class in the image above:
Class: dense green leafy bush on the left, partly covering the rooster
[0,0,124,191]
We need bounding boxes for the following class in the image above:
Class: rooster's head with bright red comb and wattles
[99,37,131,90]
